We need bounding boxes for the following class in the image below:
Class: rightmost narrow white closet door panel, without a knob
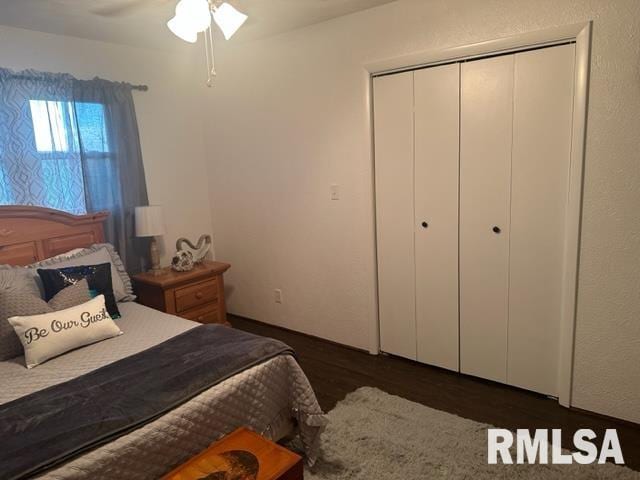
[508,45,575,395]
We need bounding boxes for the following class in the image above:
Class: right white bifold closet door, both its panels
[460,45,575,395]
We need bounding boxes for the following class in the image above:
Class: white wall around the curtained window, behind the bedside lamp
[0,26,212,264]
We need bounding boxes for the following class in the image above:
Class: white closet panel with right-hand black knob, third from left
[460,55,514,382]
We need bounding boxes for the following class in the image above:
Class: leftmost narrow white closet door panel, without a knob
[373,72,416,360]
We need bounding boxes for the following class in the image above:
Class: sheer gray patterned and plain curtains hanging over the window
[0,69,148,273]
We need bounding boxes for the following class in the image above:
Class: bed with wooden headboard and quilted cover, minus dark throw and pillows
[0,207,326,479]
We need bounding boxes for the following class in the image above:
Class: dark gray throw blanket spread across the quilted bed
[0,325,314,479]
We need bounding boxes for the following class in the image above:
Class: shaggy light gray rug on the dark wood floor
[305,387,640,480]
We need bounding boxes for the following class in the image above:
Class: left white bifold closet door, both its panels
[373,64,460,370]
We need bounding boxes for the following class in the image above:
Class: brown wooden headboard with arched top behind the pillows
[0,205,109,265]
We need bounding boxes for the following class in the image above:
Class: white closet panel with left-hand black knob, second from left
[414,64,460,371]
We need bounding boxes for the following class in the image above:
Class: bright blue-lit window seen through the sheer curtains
[0,99,112,214]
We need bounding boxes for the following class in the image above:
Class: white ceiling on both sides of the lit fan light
[0,0,394,49]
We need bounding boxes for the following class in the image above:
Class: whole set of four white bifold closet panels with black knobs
[373,44,575,396]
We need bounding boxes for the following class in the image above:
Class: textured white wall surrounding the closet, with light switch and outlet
[207,0,640,422]
